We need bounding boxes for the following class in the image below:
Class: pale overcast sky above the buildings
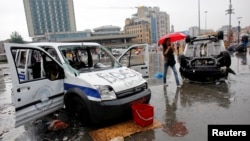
[0,0,250,41]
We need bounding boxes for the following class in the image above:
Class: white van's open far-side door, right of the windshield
[118,44,149,78]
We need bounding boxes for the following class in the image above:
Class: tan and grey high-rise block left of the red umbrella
[124,6,170,44]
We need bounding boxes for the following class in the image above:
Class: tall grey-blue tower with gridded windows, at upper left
[23,0,76,40]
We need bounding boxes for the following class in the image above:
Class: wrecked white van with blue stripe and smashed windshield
[4,42,151,127]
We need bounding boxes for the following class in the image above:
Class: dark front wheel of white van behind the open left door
[65,96,89,126]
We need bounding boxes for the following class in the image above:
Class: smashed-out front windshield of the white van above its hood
[59,45,121,74]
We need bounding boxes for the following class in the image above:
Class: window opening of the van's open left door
[12,49,64,83]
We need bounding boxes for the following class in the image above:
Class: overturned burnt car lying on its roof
[179,31,235,82]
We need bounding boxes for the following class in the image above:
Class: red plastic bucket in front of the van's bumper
[132,103,154,126]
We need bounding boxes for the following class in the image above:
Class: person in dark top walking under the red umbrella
[162,38,181,87]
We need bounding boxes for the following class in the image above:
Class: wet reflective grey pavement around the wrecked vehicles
[0,50,250,141]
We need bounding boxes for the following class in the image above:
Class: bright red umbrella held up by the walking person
[158,32,186,45]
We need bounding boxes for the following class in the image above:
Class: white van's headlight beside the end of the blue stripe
[96,85,117,100]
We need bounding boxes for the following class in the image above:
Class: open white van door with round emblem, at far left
[4,43,64,127]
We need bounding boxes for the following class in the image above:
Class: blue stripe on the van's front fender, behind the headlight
[64,83,101,98]
